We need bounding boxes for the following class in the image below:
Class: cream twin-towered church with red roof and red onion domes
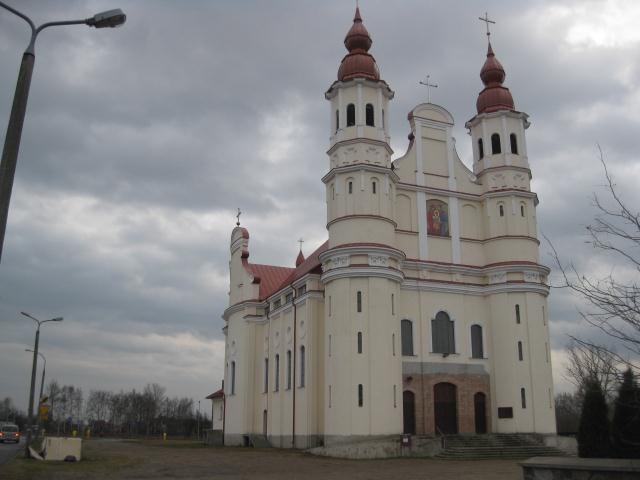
[223,9,555,448]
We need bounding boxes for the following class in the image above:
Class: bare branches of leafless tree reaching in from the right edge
[547,146,640,371]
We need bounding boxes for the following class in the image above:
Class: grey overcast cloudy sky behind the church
[0,0,640,409]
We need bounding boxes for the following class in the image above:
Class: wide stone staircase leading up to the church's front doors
[436,433,567,460]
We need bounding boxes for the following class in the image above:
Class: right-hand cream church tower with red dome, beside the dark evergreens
[465,33,555,432]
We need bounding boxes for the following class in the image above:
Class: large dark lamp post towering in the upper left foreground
[0,1,127,260]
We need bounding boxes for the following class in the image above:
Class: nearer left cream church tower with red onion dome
[320,8,404,442]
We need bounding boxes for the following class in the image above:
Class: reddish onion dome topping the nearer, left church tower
[338,7,380,81]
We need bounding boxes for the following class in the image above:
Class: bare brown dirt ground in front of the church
[0,440,522,480]
